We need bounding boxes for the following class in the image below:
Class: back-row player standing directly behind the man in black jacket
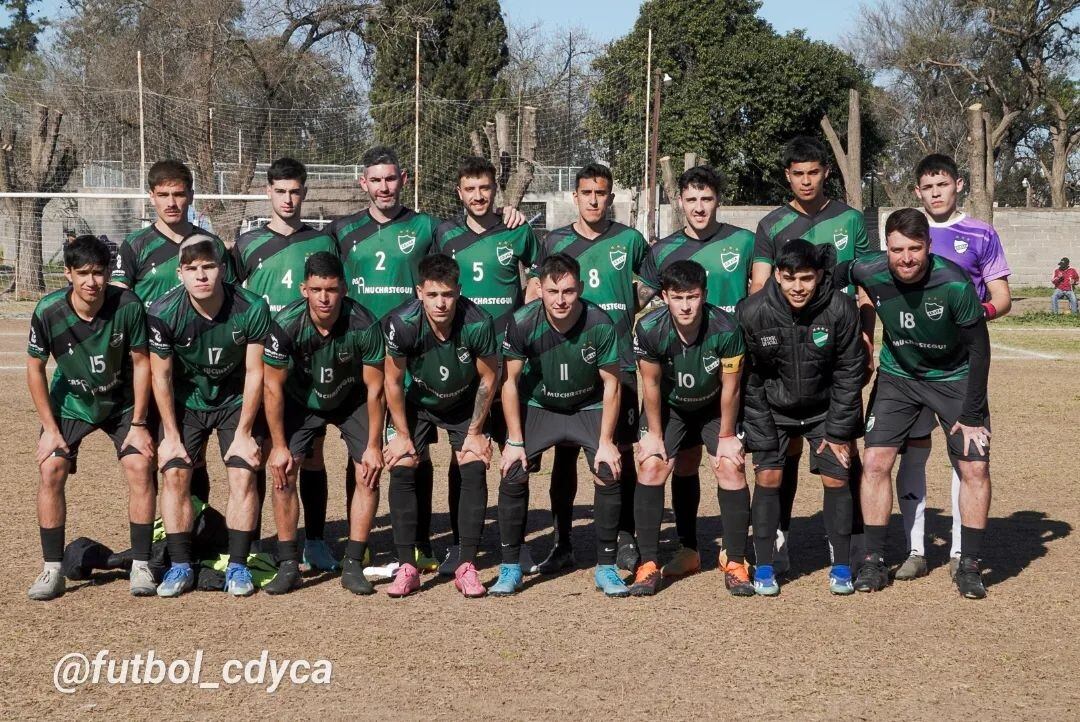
[750,136,874,573]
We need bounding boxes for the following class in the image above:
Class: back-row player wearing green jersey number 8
[527,163,652,574]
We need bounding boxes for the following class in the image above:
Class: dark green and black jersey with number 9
[382,298,499,411]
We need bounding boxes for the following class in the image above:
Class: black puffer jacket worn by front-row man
[735,264,866,451]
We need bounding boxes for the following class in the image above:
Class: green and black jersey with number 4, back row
[232,224,338,313]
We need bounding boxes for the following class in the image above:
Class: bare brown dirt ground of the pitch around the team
[0,310,1080,720]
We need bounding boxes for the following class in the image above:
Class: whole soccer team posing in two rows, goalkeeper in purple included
[26,136,1011,603]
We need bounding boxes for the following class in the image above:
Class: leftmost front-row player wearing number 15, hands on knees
[26,235,156,601]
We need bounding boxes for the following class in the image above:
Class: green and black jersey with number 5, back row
[434,220,537,342]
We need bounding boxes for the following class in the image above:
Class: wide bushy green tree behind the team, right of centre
[589,0,881,203]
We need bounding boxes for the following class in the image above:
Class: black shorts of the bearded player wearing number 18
[865,373,990,461]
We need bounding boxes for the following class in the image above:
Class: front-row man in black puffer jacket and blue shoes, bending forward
[735,239,866,596]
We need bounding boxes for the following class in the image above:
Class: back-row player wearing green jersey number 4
[232,158,338,572]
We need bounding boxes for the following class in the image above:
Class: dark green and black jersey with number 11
[502,300,619,411]
